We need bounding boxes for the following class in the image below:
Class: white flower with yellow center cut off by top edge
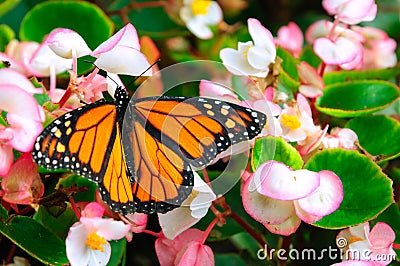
[179,0,222,39]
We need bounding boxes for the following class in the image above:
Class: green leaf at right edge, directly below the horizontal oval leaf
[346,115,400,162]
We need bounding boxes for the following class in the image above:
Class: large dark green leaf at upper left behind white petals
[20,1,114,49]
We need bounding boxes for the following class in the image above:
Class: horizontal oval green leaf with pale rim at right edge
[316,80,400,117]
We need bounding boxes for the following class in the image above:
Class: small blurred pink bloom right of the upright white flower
[275,22,304,56]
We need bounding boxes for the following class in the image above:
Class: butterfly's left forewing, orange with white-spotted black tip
[32,102,117,181]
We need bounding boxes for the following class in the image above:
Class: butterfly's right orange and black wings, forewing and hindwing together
[123,96,266,213]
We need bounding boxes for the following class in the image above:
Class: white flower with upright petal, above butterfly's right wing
[219,18,276,78]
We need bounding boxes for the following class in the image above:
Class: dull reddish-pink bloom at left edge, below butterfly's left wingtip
[0,153,44,204]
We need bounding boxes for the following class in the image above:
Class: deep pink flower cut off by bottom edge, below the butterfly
[155,229,215,266]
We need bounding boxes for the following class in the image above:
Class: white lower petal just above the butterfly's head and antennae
[94,46,152,76]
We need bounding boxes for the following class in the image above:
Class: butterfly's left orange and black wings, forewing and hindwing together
[32,101,133,212]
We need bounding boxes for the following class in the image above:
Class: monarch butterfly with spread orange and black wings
[32,75,266,214]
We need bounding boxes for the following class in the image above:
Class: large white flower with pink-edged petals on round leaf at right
[242,161,343,235]
